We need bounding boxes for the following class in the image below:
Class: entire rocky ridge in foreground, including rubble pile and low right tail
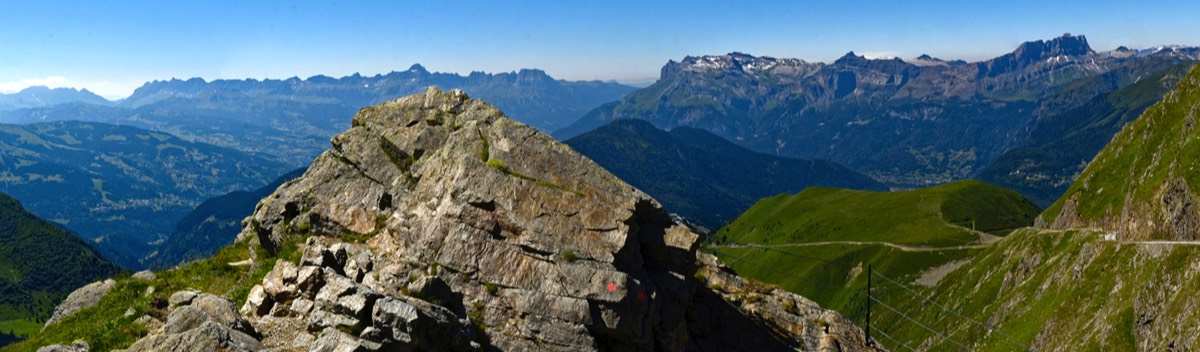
[51,88,872,351]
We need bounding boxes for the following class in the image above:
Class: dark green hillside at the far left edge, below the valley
[0,193,121,340]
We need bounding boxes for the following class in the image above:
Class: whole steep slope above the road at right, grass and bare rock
[1042,62,1200,240]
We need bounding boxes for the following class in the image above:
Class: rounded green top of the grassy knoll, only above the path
[715,180,1038,246]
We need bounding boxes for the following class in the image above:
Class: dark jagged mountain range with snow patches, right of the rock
[556,35,1200,187]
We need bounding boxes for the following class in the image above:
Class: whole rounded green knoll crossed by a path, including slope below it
[707,180,1038,318]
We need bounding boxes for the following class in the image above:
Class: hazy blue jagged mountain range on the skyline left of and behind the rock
[0,65,635,167]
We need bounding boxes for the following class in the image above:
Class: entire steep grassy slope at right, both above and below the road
[854,64,1200,351]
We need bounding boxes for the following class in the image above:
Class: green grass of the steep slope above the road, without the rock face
[1043,63,1200,222]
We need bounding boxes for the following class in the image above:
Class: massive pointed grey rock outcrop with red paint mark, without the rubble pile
[244,89,697,351]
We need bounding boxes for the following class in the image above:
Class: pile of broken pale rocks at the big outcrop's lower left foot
[241,237,482,351]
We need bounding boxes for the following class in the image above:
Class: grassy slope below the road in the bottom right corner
[872,229,1200,351]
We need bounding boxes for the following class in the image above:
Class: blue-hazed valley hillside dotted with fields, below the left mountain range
[0,121,290,268]
